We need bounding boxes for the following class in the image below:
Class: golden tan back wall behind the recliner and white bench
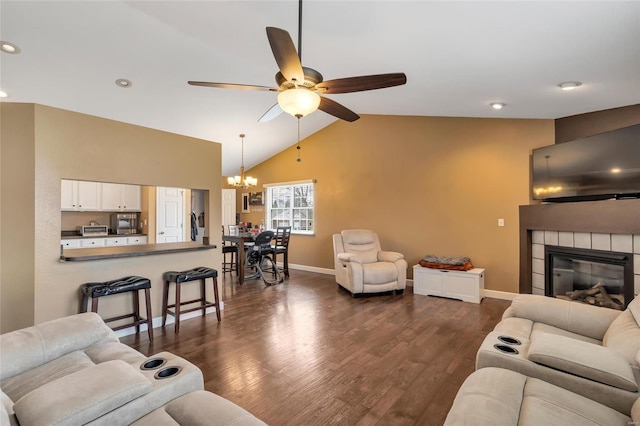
[238,115,554,293]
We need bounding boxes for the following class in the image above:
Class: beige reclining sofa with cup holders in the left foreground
[0,312,264,426]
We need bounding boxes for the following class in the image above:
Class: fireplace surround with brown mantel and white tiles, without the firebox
[519,199,640,295]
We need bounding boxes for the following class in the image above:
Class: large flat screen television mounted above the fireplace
[531,124,640,202]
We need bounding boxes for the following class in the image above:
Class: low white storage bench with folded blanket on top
[413,265,484,303]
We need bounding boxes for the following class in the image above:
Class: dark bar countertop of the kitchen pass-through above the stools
[60,242,217,262]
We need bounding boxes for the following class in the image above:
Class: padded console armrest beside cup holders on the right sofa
[528,333,638,392]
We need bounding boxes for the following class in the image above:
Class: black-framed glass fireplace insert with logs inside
[544,245,634,310]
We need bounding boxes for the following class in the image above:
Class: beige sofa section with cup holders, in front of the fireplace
[476,294,640,416]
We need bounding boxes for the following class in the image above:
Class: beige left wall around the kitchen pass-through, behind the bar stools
[0,103,221,332]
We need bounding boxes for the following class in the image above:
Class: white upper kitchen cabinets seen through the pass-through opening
[60,179,142,211]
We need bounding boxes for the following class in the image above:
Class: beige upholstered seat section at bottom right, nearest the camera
[444,367,640,426]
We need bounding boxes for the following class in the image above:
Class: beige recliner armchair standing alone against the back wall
[333,229,407,296]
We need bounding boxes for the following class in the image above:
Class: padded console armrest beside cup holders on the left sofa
[13,360,153,426]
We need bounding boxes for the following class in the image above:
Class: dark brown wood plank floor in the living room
[121,271,509,426]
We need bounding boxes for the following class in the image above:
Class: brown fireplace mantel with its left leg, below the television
[519,199,640,293]
